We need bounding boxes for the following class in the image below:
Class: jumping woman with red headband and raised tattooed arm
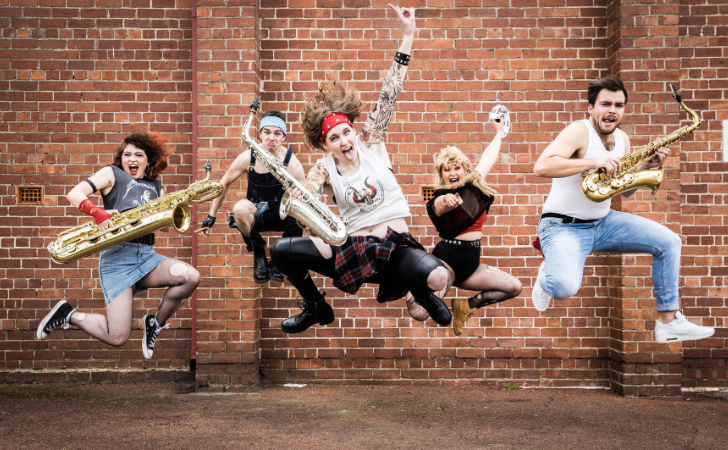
[271,5,452,333]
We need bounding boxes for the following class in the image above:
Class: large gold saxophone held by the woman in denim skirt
[48,161,222,264]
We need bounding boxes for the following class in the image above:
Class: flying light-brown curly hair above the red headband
[301,81,361,150]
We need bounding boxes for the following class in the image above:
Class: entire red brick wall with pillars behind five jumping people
[0,0,728,394]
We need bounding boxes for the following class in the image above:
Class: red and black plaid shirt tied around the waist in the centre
[334,228,425,303]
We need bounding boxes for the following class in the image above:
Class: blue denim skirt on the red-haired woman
[99,242,167,305]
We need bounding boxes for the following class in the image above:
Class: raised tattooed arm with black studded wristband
[362,5,416,160]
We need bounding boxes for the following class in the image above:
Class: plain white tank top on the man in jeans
[543,119,625,220]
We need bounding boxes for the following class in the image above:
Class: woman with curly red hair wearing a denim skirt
[37,133,200,359]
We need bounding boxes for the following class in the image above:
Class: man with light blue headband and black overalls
[202,110,305,283]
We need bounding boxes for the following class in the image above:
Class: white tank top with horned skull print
[318,139,410,233]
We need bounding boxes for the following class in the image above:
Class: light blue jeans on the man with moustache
[538,210,682,311]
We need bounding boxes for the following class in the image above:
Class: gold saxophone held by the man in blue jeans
[581,84,700,202]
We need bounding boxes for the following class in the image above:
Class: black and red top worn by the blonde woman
[427,184,493,239]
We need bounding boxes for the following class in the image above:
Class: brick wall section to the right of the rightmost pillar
[678,1,728,387]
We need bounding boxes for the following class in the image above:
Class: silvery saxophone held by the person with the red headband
[243,97,348,246]
